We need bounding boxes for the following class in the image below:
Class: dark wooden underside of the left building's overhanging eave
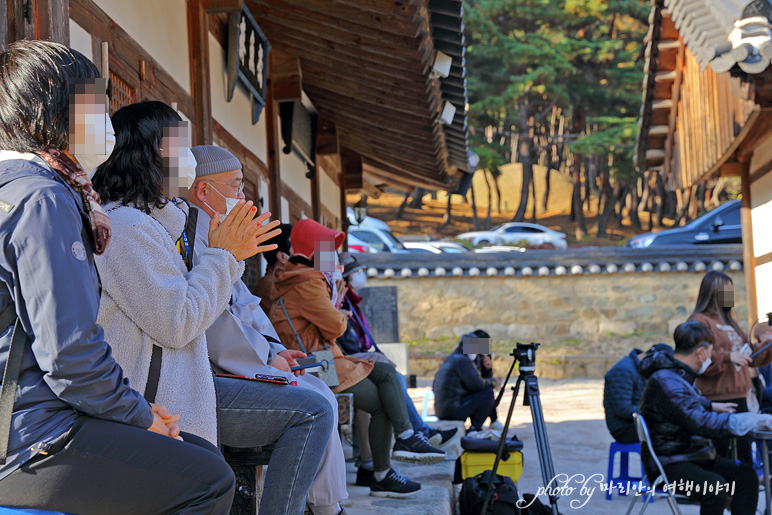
[245,0,468,190]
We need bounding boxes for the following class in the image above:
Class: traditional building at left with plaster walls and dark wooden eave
[0,0,470,290]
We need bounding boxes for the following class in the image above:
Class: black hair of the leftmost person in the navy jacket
[0,40,99,152]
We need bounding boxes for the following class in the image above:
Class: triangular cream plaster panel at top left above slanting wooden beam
[95,0,190,93]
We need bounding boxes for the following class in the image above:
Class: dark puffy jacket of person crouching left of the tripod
[432,335,496,418]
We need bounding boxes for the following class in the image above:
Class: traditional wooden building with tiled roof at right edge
[636,0,772,328]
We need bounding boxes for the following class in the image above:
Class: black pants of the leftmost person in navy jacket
[0,416,235,515]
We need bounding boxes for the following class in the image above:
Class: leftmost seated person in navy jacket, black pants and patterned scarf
[0,41,235,515]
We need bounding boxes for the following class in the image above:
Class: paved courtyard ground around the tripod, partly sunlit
[347,379,763,515]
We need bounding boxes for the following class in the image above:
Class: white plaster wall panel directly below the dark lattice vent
[209,34,268,163]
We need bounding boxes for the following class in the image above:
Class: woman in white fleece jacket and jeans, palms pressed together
[94,101,333,515]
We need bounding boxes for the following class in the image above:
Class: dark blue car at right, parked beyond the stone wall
[627,200,742,249]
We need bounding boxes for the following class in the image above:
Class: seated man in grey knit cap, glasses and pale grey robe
[188,146,348,515]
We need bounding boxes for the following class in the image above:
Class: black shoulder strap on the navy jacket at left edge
[0,303,27,465]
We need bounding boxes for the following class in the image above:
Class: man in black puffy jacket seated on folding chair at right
[640,320,769,515]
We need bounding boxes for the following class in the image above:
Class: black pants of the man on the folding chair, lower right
[665,457,759,515]
